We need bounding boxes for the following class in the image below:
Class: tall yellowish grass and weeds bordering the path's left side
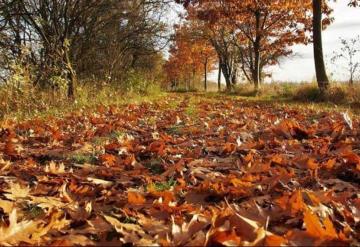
[0,66,161,119]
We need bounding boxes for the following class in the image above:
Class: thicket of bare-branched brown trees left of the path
[0,0,168,98]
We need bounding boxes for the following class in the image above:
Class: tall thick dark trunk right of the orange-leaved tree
[313,0,329,93]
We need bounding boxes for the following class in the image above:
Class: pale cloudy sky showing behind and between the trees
[169,0,360,82]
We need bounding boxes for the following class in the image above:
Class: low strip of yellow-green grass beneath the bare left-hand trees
[0,82,167,121]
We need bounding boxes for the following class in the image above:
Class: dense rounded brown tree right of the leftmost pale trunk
[72,0,168,83]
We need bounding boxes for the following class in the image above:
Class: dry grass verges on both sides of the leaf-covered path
[0,82,360,120]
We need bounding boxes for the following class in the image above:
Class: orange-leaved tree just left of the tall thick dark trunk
[183,0,311,91]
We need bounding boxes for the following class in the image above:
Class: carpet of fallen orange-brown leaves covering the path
[0,94,360,246]
